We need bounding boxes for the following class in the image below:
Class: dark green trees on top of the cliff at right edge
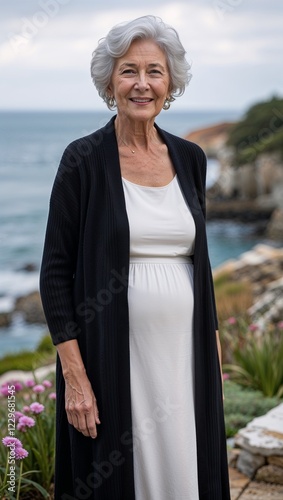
[227,97,283,166]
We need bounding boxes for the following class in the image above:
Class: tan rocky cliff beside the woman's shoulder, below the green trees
[186,122,283,242]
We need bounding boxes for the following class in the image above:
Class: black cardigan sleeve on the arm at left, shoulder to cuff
[40,147,80,345]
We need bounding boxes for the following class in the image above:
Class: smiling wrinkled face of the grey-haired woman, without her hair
[109,39,170,121]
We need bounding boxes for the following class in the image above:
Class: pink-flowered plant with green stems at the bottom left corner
[0,379,56,499]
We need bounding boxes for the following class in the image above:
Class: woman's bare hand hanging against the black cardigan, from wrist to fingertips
[65,373,100,438]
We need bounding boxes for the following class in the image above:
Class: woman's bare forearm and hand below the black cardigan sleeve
[57,339,100,438]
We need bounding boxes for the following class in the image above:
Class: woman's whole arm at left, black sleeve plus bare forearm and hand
[40,145,100,438]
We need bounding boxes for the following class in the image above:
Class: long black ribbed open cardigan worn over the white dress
[40,116,230,500]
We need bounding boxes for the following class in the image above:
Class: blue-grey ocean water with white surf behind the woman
[0,109,266,357]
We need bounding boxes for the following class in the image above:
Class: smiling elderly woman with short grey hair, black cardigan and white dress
[41,16,230,500]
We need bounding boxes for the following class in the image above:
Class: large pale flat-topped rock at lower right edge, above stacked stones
[235,403,283,457]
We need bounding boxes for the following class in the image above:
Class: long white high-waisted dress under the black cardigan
[122,176,199,500]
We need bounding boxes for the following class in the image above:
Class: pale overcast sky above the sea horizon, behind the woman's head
[0,0,283,110]
